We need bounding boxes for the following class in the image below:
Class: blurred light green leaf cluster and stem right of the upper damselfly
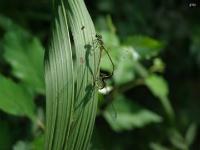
[101,26,174,122]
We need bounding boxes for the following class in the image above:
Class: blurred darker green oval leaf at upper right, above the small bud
[125,36,163,59]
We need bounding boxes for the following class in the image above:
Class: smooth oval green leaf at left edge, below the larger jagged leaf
[0,75,35,120]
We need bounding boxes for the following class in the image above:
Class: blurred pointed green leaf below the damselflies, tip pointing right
[104,96,162,132]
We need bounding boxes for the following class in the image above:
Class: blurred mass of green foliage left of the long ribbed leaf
[0,16,44,150]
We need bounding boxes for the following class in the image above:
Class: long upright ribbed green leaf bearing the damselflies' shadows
[45,0,99,150]
